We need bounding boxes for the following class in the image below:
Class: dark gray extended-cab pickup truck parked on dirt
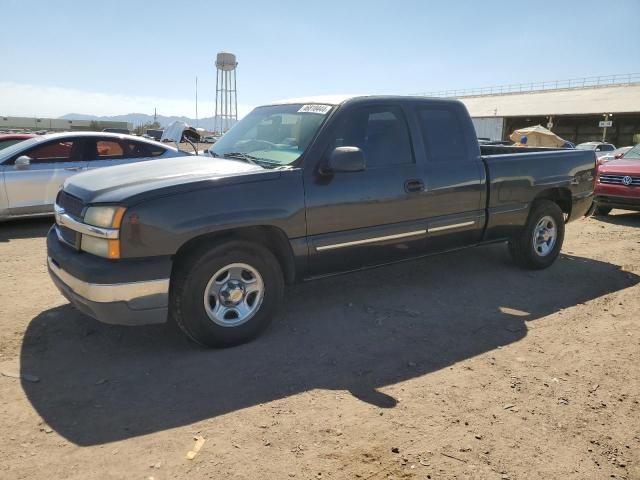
[47,96,596,346]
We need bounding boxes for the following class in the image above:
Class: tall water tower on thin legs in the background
[214,52,238,133]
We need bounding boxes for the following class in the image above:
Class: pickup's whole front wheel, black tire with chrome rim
[170,241,284,347]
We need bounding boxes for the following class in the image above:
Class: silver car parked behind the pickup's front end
[0,132,187,220]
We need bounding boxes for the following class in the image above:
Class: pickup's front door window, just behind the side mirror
[330,106,413,168]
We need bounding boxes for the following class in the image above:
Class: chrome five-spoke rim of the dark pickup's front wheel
[204,263,264,327]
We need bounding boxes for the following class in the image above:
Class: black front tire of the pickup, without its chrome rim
[169,241,284,347]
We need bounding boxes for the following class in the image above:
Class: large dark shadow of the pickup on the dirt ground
[21,245,640,445]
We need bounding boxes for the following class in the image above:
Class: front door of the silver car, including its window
[3,138,87,215]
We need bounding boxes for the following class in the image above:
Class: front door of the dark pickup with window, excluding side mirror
[305,104,426,275]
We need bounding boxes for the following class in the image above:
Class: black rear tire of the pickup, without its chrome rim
[509,200,564,270]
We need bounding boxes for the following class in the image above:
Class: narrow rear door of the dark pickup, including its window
[415,102,486,251]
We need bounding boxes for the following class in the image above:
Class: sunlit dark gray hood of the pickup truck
[64,155,272,203]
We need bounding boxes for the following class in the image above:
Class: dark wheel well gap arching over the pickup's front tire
[173,225,296,284]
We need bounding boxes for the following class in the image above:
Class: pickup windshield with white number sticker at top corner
[209,104,333,167]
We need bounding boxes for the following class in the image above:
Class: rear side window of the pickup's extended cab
[418,108,467,162]
